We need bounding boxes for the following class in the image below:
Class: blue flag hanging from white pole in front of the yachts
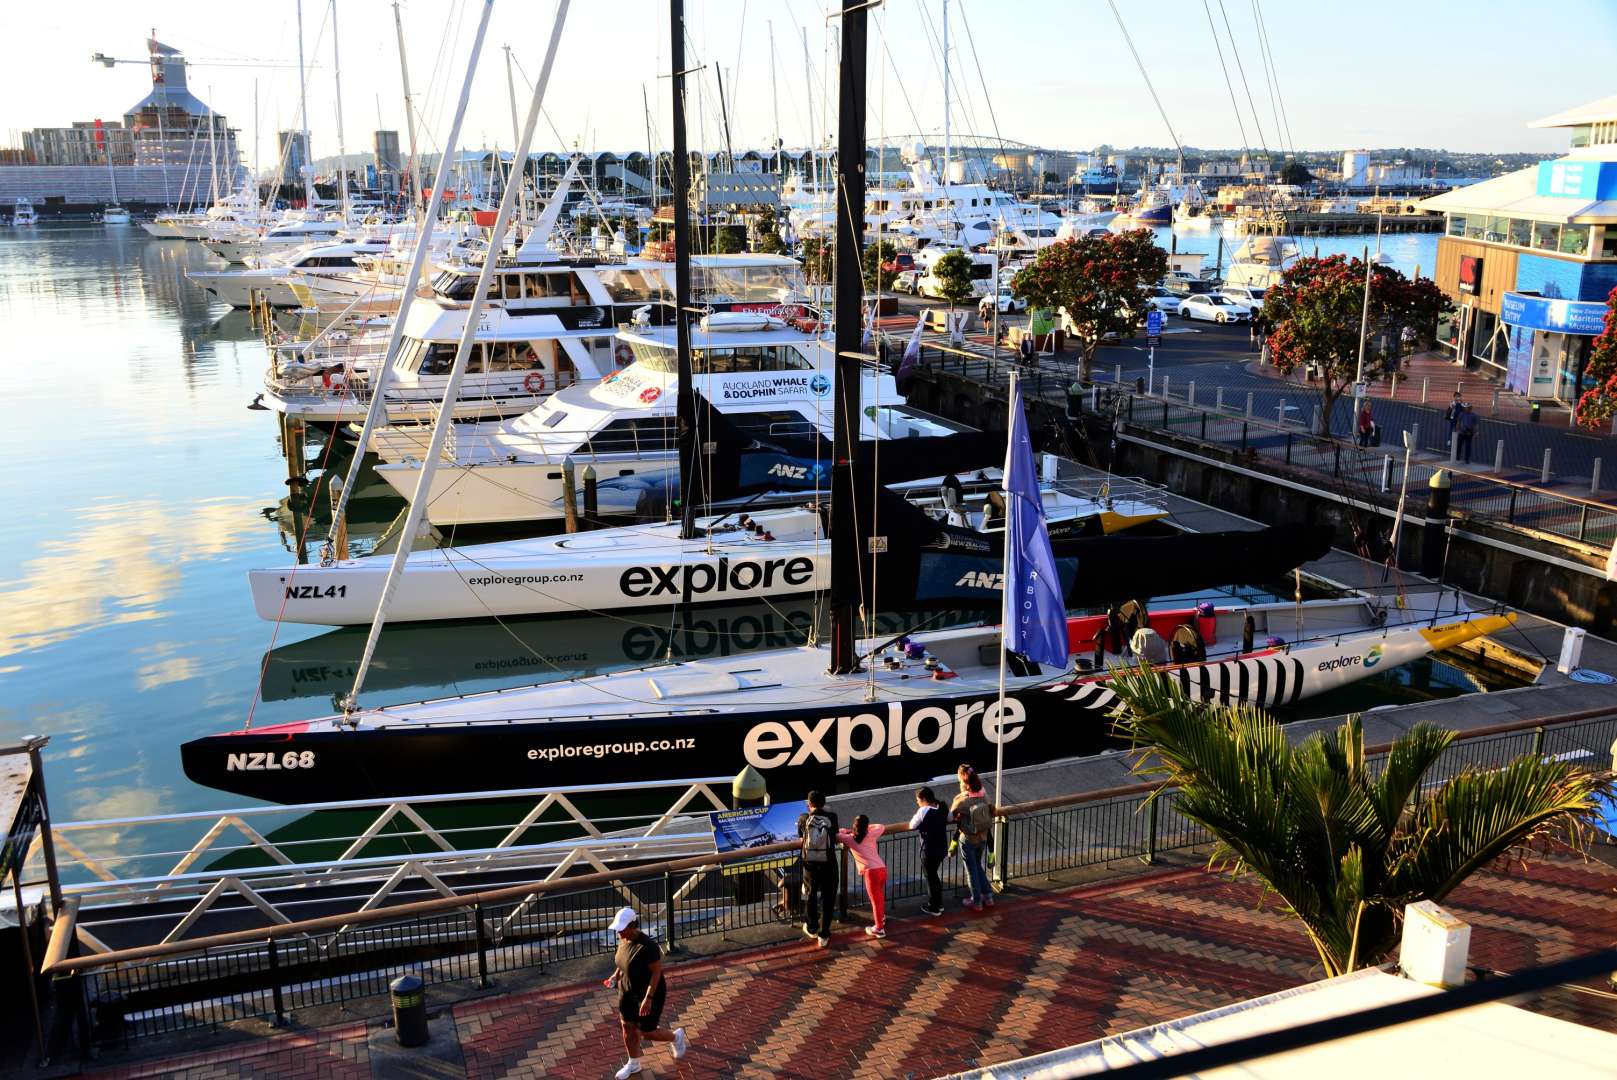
[1004,383,1067,671]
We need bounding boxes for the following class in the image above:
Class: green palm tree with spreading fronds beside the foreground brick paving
[1112,668,1612,978]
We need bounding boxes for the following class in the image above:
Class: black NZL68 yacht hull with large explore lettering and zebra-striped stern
[181,616,1512,802]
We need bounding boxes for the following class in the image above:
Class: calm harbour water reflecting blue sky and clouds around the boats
[0,225,1476,820]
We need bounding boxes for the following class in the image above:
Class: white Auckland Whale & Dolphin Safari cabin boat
[367,312,959,527]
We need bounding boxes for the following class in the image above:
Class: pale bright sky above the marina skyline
[9,0,1617,168]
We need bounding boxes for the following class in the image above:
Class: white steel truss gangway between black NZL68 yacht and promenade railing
[14,776,733,952]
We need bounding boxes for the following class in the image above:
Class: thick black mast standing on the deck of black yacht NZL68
[830,0,868,674]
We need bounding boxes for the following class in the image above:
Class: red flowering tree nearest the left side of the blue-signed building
[1263,255,1452,435]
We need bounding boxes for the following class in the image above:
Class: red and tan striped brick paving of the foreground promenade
[75,854,1617,1080]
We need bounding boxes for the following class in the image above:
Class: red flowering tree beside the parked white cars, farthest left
[1011,228,1167,382]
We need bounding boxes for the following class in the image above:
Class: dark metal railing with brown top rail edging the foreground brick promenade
[42,708,1617,1046]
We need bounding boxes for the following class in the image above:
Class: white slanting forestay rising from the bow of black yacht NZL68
[343,0,569,715]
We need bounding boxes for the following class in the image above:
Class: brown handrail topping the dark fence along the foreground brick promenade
[40,705,1617,975]
